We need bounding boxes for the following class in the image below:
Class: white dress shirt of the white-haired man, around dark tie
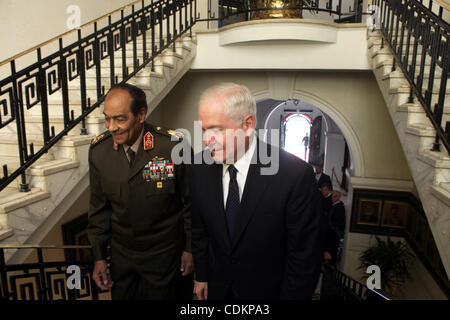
[222,136,256,207]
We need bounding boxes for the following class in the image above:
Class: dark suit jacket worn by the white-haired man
[189,141,324,300]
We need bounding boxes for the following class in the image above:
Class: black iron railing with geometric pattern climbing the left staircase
[0,0,196,191]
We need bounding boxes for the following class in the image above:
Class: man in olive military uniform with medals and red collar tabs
[88,84,193,299]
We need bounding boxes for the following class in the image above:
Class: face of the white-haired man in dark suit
[198,95,254,164]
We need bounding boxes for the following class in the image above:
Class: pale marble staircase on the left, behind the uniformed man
[0,35,197,263]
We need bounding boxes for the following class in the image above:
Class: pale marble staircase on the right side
[367,30,450,278]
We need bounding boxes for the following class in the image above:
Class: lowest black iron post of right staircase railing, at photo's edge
[431,35,450,151]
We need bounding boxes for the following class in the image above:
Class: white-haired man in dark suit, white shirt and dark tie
[190,83,324,300]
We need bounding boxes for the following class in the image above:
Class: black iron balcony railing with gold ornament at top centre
[198,0,364,27]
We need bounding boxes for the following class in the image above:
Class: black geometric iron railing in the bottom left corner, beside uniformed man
[0,245,109,300]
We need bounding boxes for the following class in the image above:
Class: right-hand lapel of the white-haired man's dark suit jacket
[232,140,269,248]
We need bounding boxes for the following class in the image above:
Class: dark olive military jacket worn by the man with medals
[88,123,191,296]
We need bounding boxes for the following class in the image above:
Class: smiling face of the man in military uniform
[103,89,146,145]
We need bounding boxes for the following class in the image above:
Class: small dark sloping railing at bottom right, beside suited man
[320,264,390,301]
